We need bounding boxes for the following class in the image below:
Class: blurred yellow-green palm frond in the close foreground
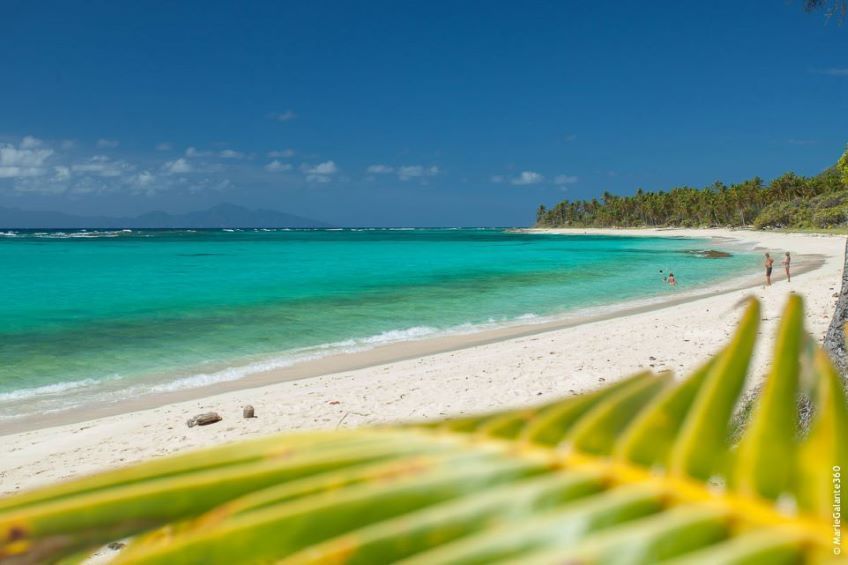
[0,296,848,565]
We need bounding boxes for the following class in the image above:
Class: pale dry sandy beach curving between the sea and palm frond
[0,229,845,494]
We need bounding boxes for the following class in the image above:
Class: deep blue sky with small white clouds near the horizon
[0,0,848,225]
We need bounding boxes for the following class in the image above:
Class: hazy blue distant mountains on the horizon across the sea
[0,204,330,229]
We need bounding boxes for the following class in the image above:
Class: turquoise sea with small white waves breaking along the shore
[0,229,758,421]
